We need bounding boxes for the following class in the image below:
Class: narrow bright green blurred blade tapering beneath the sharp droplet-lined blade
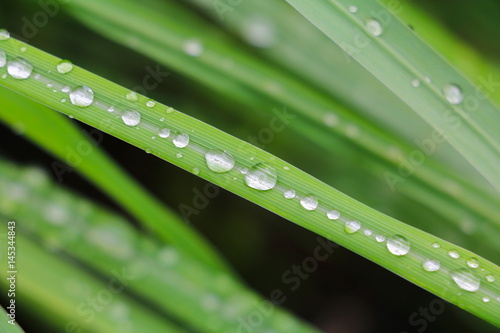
[0,87,229,271]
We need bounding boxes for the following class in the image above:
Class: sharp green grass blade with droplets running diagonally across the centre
[0,38,500,326]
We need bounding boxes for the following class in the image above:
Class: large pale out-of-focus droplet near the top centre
[243,16,276,48]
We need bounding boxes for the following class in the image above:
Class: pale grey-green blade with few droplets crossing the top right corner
[287,0,500,190]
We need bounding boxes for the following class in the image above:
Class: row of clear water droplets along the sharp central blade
[0,31,494,302]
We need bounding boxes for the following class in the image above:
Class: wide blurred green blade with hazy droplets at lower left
[0,161,316,333]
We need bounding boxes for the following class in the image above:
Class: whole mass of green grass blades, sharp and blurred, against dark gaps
[0,0,500,332]
